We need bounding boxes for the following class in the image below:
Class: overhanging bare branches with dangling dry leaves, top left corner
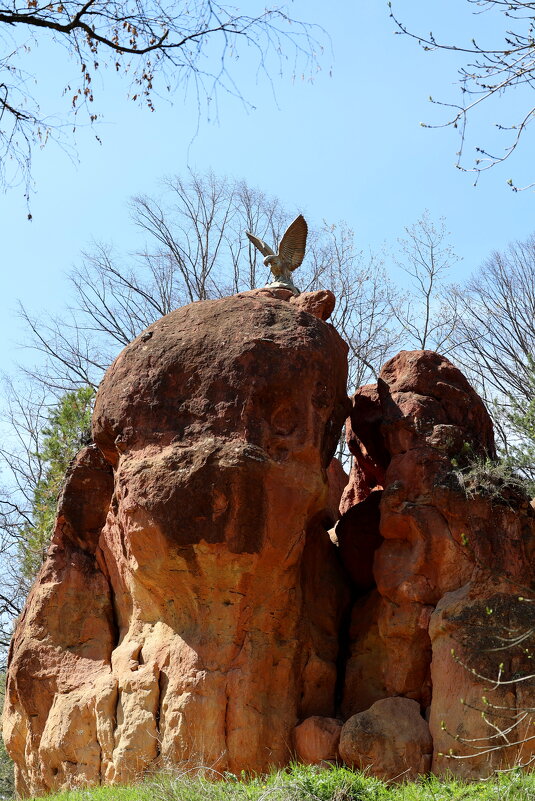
[0,0,323,196]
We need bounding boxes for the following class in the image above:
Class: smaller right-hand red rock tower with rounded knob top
[337,351,535,776]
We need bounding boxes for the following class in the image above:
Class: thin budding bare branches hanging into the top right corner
[388,0,535,191]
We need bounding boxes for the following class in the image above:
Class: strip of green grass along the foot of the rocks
[24,765,535,801]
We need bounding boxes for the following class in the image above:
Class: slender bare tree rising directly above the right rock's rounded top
[391,211,458,355]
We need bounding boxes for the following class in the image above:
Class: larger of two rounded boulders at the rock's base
[339,698,433,780]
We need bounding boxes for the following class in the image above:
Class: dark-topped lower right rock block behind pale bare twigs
[429,528,535,778]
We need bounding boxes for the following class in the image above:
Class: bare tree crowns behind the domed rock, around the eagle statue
[17,174,398,394]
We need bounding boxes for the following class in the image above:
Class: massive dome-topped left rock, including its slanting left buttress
[4,292,348,795]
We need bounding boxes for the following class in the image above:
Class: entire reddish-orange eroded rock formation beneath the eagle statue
[4,290,535,795]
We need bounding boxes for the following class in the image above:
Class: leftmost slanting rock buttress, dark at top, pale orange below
[4,445,117,795]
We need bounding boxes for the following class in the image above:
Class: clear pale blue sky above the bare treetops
[0,0,535,370]
